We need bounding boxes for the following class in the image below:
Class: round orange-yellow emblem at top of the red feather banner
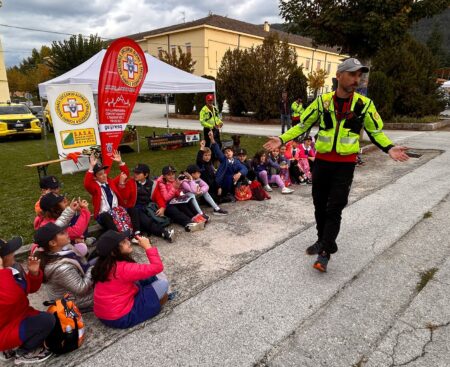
[117,46,144,87]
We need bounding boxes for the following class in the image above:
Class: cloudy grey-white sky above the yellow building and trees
[0,0,281,66]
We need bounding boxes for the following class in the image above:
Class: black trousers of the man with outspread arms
[312,159,355,254]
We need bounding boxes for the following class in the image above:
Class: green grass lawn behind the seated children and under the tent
[0,127,267,243]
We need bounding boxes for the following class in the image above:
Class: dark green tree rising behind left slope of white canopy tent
[48,34,105,76]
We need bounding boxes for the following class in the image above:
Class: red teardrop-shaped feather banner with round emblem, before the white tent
[98,38,148,170]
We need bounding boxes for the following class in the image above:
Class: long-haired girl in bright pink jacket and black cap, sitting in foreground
[92,230,169,329]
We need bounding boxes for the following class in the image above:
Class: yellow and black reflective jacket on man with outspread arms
[280,92,394,155]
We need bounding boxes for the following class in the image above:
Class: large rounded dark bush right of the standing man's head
[369,37,445,117]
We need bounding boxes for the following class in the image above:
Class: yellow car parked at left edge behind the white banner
[0,103,42,139]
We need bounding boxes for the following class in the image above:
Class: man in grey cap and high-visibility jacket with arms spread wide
[264,58,408,272]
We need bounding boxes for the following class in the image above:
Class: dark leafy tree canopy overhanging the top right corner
[279,0,450,59]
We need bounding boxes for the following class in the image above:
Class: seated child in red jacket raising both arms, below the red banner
[84,150,140,237]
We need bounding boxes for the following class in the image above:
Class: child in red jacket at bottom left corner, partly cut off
[0,237,55,364]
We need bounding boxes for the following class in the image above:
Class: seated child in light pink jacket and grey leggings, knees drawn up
[181,164,228,215]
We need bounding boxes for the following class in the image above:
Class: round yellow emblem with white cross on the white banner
[55,92,91,125]
